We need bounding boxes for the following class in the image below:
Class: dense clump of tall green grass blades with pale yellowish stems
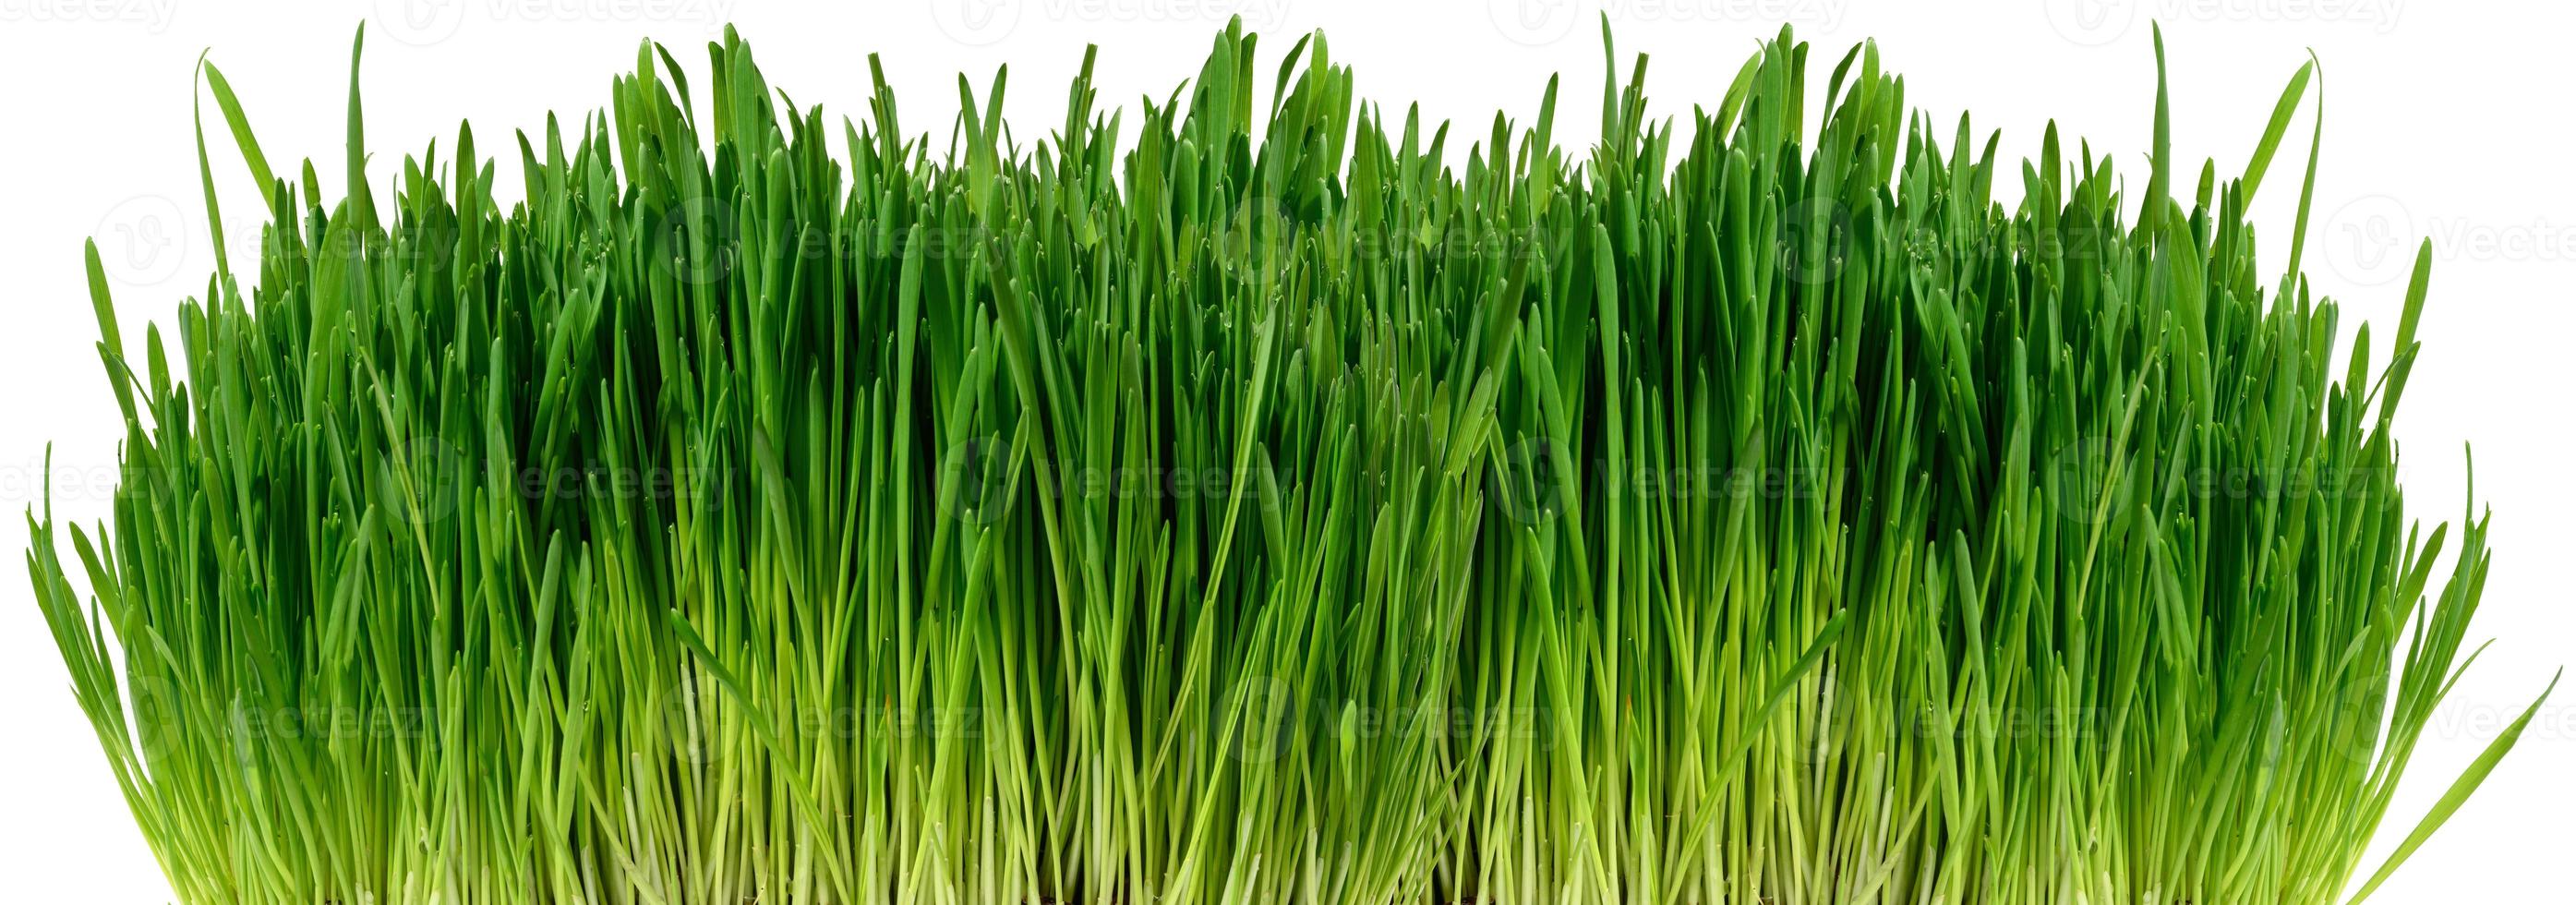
[29,16,2537,905]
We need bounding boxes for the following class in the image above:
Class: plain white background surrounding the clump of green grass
[0,0,2576,902]
